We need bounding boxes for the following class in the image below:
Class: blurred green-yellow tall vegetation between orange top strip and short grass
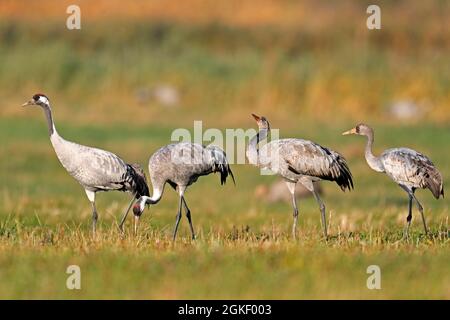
[0,7,450,126]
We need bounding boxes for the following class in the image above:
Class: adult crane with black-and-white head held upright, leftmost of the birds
[22,93,149,234]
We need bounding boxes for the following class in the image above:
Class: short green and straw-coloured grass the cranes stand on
[0,118,450,299]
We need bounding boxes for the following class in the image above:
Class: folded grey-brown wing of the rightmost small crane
[380,148,444,198]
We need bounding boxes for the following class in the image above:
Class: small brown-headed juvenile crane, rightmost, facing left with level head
[343,123,444,237]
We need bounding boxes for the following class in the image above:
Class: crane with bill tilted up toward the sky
[247,114,353,239]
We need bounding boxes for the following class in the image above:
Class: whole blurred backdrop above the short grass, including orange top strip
[0,0,450,127]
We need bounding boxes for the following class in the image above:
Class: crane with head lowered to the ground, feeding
[133,142,235,240]
